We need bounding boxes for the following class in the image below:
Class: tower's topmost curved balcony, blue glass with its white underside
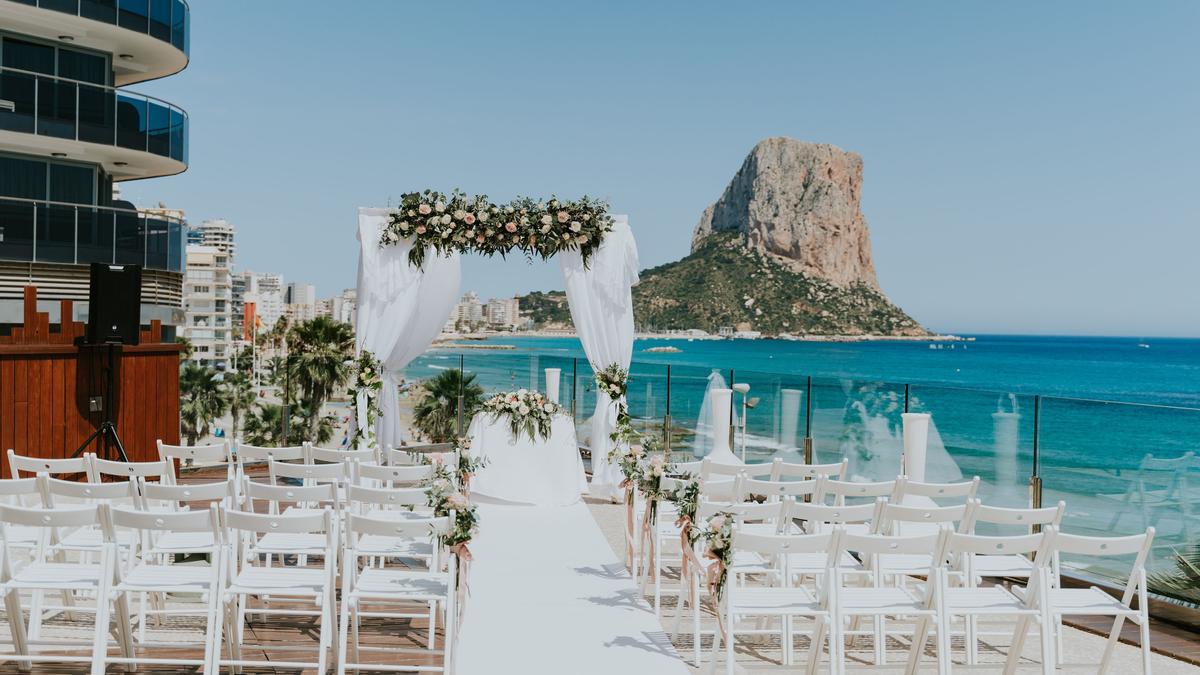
[0,0,191,85]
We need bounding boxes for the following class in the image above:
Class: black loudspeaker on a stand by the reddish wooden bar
[86,263,142,345]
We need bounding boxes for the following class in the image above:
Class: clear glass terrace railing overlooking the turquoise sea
[406,351,1200,603]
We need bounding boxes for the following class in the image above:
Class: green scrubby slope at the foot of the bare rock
[634,232,926,335]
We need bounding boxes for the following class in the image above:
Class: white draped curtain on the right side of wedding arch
[559,216,638,498]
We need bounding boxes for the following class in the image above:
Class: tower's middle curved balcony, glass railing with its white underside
[0,68,187,180]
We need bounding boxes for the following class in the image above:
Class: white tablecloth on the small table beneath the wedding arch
[467,413,588,506]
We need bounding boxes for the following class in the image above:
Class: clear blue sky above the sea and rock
[125,0,1200,336]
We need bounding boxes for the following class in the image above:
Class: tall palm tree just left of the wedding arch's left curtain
[287,316,354,438]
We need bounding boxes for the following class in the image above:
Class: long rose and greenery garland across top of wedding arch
[379,190,612,267]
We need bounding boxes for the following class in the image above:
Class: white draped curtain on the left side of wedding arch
[355,208,461,447]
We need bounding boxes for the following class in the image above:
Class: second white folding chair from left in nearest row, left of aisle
[104,503,223,673]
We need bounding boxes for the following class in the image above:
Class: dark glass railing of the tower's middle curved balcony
[0,67,187,165]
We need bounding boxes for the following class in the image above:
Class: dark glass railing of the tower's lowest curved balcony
[0,197,185,271]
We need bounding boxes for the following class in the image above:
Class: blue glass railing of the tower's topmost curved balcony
[17,0,191,54]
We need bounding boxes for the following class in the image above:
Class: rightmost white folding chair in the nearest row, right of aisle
[1006,527,1154,675]
